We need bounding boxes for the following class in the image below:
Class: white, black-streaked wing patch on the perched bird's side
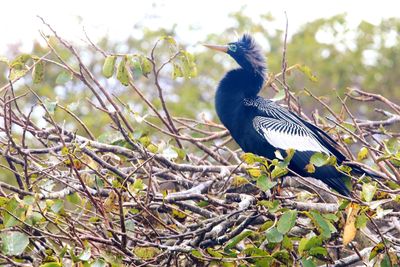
[253,116,330,154]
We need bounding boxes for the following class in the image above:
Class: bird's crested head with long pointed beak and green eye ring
[205,34,266,76]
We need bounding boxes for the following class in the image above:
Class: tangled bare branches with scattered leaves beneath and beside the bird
[0,18,400,266]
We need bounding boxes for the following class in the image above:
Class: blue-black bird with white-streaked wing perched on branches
[205,34,375,196]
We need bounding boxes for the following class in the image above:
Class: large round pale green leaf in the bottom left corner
[1,232,29,256]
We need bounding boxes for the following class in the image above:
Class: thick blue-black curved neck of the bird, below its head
[215,68,264,129]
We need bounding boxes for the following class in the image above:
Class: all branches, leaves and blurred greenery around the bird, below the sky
[0,12,400,266]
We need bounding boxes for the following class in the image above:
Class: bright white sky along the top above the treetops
[0,0,400,55]
